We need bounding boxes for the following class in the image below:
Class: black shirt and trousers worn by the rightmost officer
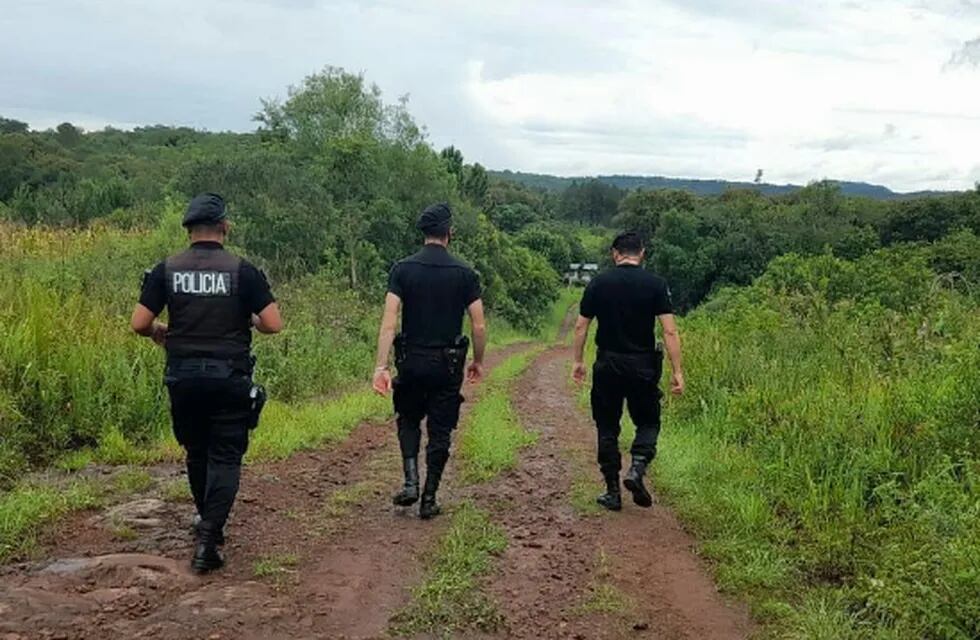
[579,264,672,502]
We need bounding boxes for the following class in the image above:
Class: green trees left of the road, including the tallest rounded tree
[0,68,586,329]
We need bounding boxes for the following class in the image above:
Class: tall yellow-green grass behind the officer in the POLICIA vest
[0,212,376,478]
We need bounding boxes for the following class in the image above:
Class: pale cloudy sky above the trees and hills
[0,0,980,191]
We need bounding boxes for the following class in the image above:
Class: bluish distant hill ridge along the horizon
[489,171,941,200]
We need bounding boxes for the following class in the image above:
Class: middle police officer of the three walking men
[373,204,486,519]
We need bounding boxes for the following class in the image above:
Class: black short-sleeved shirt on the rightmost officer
[579,265,673,353]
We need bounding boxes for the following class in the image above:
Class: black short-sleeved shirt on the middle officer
[388,244,481,347]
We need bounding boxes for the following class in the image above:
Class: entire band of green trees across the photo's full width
[0,68,980,328]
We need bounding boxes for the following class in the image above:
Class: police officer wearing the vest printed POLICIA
[132,193,282,573]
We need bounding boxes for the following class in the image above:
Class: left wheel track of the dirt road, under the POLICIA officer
[0,345,528,640]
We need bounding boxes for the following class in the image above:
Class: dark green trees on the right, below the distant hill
[502,175,980,310]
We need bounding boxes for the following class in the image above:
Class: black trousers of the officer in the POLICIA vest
[167,375,252,530]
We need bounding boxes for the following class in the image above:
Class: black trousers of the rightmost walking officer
[592,351,663,477]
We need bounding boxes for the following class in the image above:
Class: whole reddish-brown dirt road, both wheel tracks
[0,340,751,640]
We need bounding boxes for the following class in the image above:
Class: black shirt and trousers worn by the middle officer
[388,244,480,504]
